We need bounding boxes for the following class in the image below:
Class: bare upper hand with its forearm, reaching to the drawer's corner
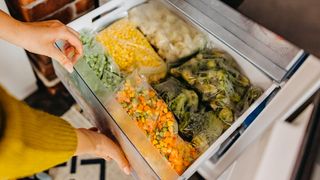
[0,10,82,72]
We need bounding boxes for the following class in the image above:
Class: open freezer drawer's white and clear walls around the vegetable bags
[54,0,306,179]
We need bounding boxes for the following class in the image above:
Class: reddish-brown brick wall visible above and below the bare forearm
[5,0,97,95]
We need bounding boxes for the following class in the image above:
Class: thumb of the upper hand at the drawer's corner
[49,46,73,73]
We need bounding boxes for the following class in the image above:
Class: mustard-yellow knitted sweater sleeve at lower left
[0,87,77,179]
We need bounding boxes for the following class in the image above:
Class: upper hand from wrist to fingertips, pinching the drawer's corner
[20,20,82,72]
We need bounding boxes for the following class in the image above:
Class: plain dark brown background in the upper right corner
[235,0,320,58]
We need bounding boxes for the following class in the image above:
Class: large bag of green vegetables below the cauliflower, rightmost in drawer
[170,50,262,125]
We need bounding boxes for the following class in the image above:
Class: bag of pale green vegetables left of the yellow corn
[80,31,122,91]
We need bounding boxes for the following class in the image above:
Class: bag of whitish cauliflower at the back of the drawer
[129,1,206,63]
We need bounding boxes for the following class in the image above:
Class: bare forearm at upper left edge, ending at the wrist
[0,10,23,45]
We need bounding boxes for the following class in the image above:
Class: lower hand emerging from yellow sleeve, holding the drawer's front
[75,128,131,175]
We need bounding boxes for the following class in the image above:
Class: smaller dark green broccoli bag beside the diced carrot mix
[155,77,227,152]
